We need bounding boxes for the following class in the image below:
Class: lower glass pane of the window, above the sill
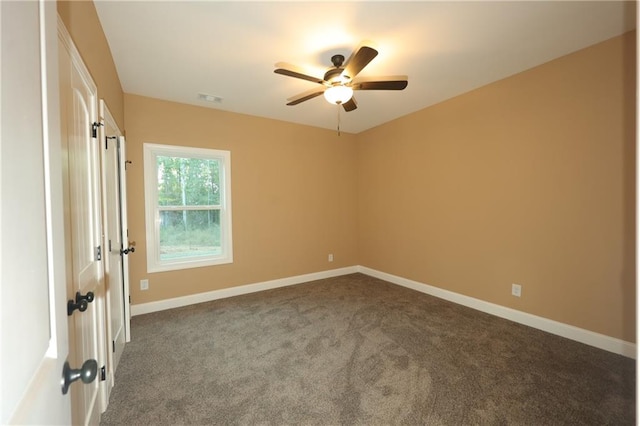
[160,210,222,260]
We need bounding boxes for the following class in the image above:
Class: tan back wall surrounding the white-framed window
[125,94,357,304]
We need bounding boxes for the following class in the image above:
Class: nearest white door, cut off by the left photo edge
[0,1,71,424]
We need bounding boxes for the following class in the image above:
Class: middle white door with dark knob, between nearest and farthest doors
[58,17,106,424]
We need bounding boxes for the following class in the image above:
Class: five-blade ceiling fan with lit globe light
[274,44,408,112]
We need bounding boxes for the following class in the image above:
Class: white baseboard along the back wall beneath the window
[131,266,358,316]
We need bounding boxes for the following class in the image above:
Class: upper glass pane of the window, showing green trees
[156,155,220,206]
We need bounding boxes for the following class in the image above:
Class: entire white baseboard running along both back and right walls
[131,266,636,359]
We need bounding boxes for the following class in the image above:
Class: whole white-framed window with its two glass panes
[144,143,233,272]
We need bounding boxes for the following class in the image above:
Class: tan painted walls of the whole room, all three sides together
[58,2,636,342]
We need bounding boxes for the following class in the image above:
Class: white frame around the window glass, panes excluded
[143,143,233,272]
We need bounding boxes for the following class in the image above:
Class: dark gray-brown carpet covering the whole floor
[101,274,636,425]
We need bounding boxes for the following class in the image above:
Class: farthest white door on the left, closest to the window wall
[100,100,131,399]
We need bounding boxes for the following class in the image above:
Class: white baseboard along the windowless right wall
[357,266,636,359]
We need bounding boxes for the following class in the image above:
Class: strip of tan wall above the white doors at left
[57,1,124,130]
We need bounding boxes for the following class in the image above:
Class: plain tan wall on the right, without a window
[358,32,636,342]
